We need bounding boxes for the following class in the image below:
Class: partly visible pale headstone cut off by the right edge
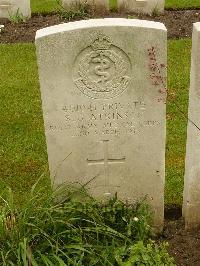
[183,23,200,228]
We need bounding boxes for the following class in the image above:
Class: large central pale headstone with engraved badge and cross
[36,19,166,229]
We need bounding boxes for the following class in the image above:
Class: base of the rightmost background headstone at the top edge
[118,0,165,14]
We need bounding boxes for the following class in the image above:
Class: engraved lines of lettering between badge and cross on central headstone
[47,101,160,137]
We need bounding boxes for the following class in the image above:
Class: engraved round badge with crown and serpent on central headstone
[73,35,131,99]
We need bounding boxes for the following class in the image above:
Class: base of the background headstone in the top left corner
[0,0,31,18]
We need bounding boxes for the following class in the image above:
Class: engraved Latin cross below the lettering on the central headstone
[87,140,126,186]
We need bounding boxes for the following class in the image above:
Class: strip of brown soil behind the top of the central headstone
[0,10,200,43]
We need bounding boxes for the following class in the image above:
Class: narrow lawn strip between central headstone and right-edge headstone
[165,39,191,205]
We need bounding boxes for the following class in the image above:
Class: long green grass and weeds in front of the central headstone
[0,179,174,266]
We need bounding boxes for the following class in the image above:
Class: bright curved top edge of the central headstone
[35,18,167,40]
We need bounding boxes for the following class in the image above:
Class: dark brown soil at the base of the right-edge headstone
[163,206,200,266]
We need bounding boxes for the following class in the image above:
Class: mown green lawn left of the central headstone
[0,44,47,206]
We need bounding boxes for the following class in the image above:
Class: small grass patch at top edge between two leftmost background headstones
[31,0,61,13]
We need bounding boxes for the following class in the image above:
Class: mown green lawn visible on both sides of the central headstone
[0,40,191,205]
